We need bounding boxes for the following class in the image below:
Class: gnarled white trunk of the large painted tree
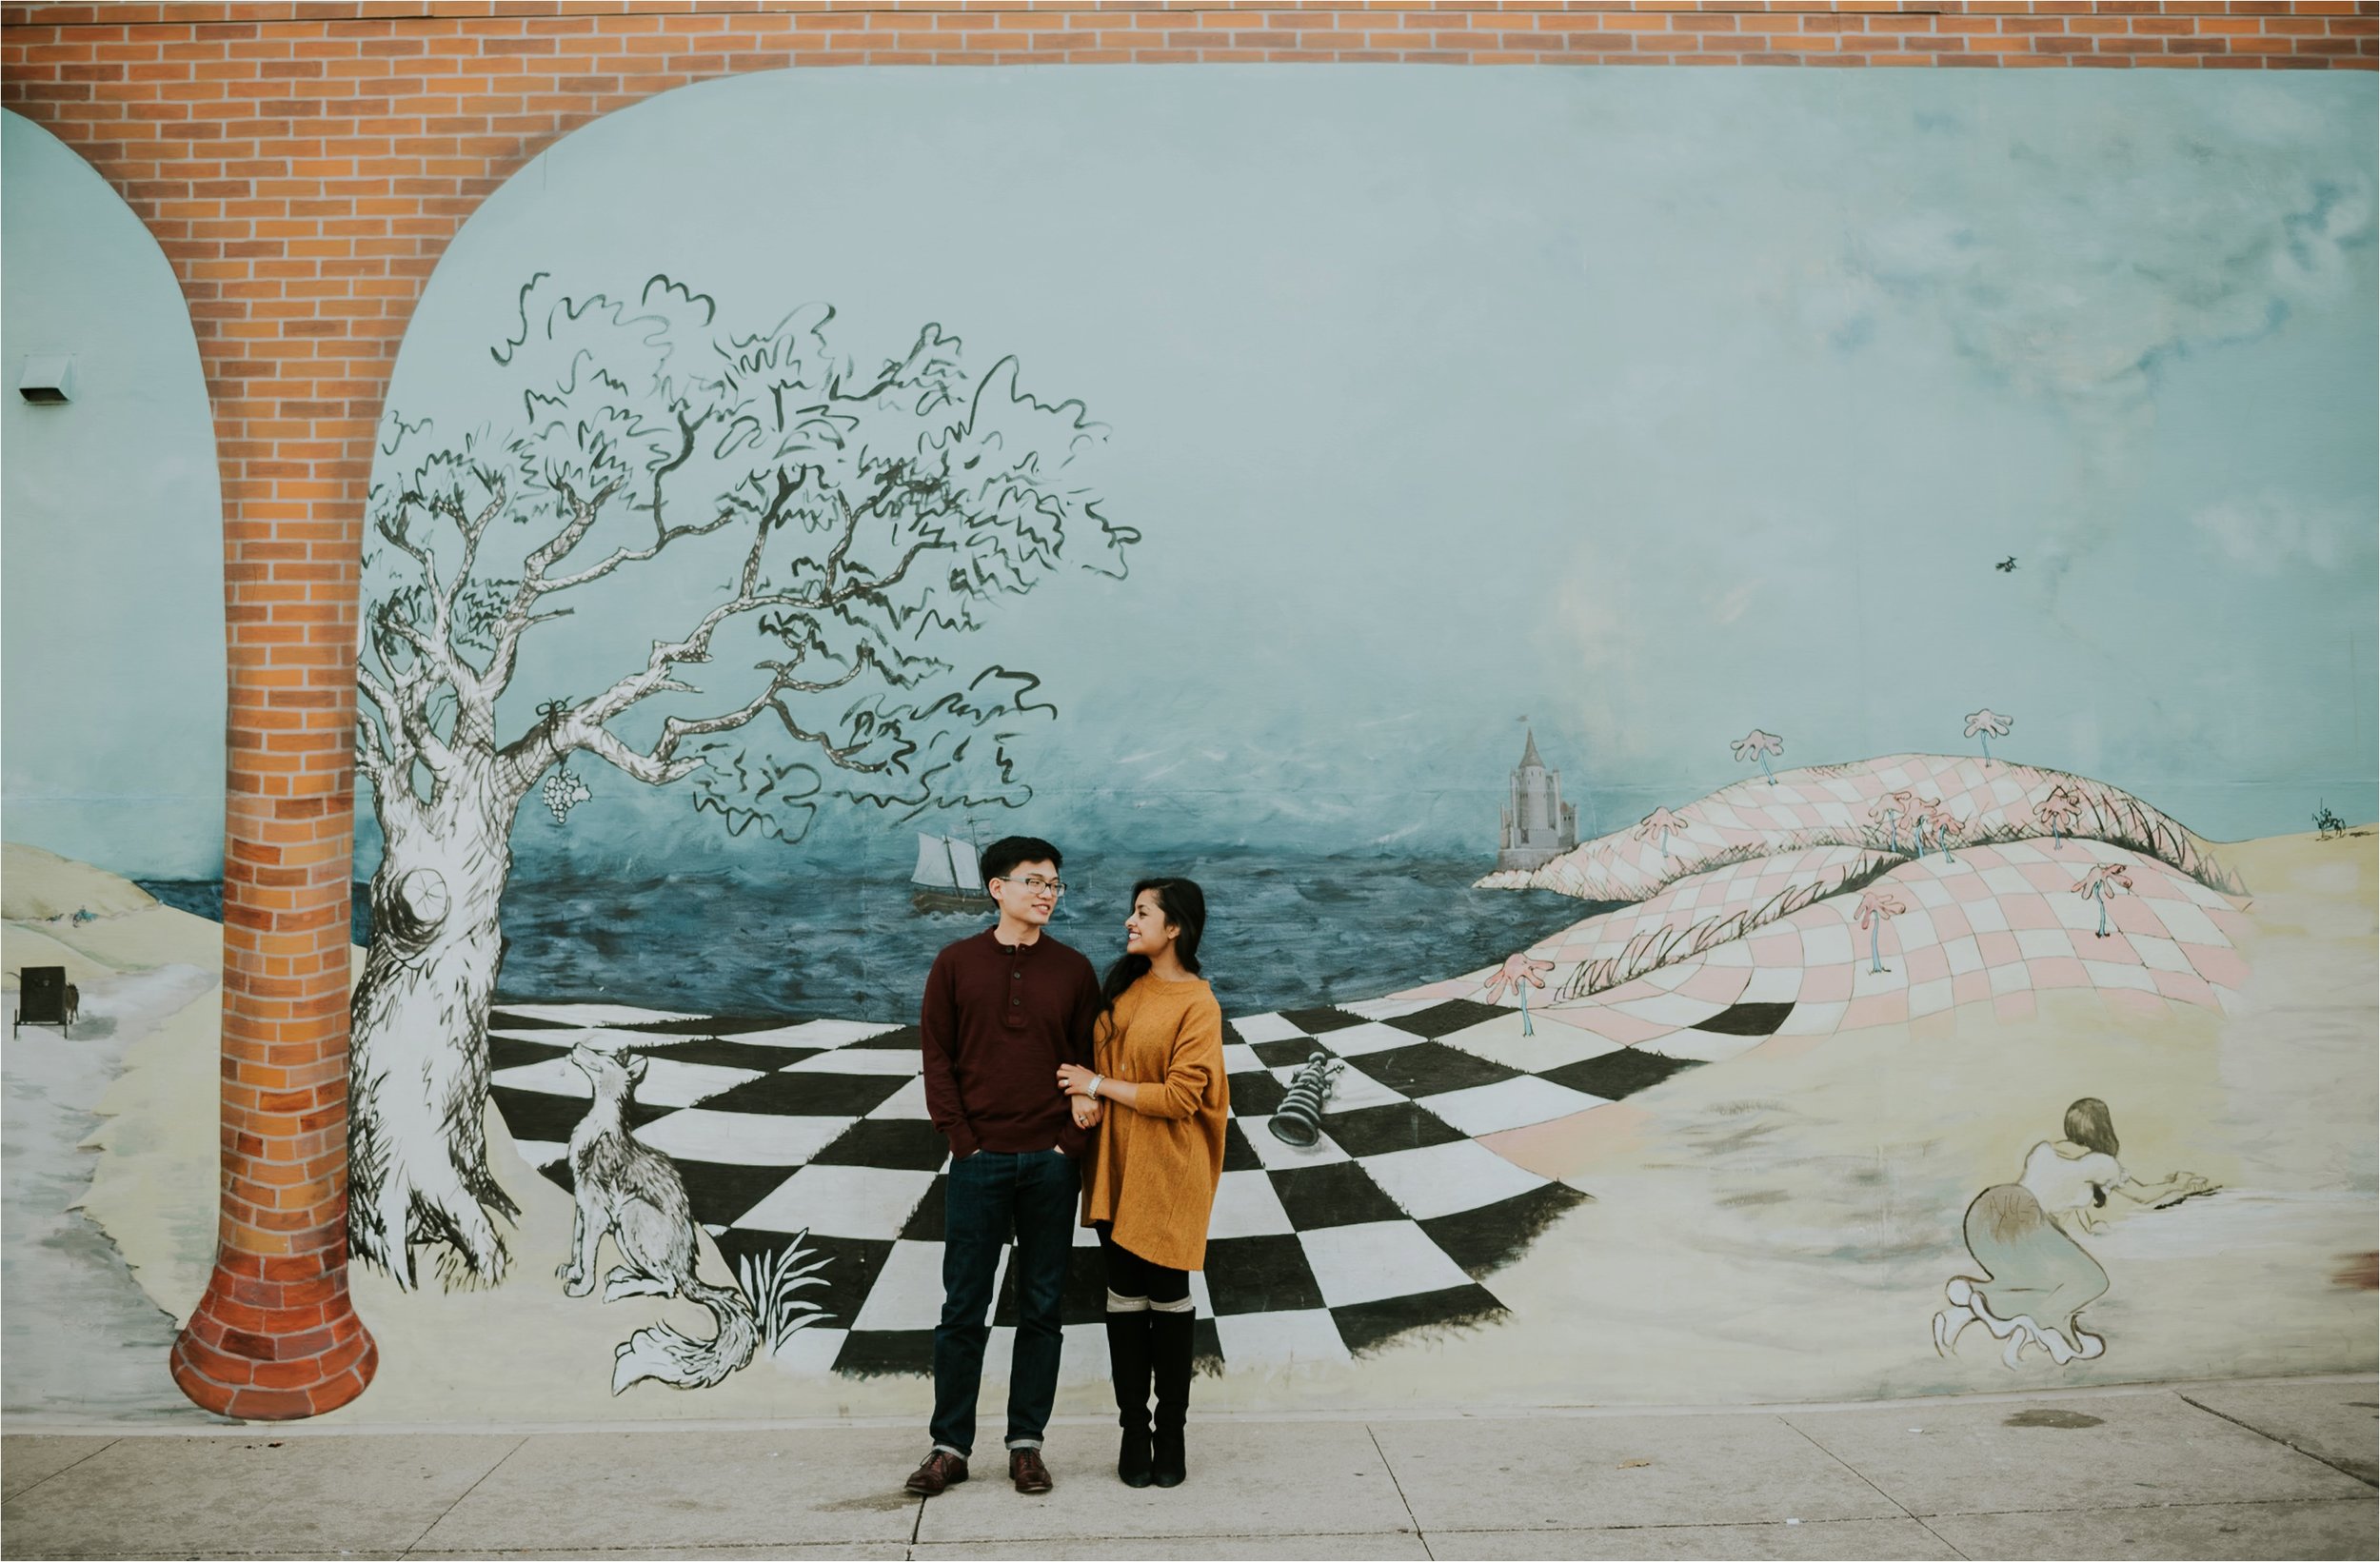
[347,760,519,1288]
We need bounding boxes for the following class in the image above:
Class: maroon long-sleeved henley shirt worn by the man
[917,929,1100,1159]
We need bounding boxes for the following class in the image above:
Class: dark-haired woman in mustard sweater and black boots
[1057,879,1231,1486]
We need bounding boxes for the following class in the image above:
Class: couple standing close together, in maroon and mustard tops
[909,836,1231,1497]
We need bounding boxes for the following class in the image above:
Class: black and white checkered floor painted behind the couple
[490,998,1752,1378]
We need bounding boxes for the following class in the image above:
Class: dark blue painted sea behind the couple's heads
[143,850,1609,1021]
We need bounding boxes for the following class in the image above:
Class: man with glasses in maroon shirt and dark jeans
[909,836,1100,1497]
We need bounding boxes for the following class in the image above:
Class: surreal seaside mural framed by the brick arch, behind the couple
[10,67,2380,1421]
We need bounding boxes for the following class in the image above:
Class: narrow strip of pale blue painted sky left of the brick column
[0,114,224,879]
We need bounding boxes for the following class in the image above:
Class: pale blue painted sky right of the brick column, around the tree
[367,67,2380,853]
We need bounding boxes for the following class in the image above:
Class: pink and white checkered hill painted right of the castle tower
[1402,755,2247,1062]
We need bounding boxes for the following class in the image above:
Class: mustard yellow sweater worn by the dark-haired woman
[1083,977,1231,1269]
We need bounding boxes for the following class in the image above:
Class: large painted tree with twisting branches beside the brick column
[347,274,1138,1286]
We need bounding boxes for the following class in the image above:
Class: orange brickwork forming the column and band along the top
[0,0,2380,1416]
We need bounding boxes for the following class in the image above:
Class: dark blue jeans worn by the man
[933,1150,1083,1457]
